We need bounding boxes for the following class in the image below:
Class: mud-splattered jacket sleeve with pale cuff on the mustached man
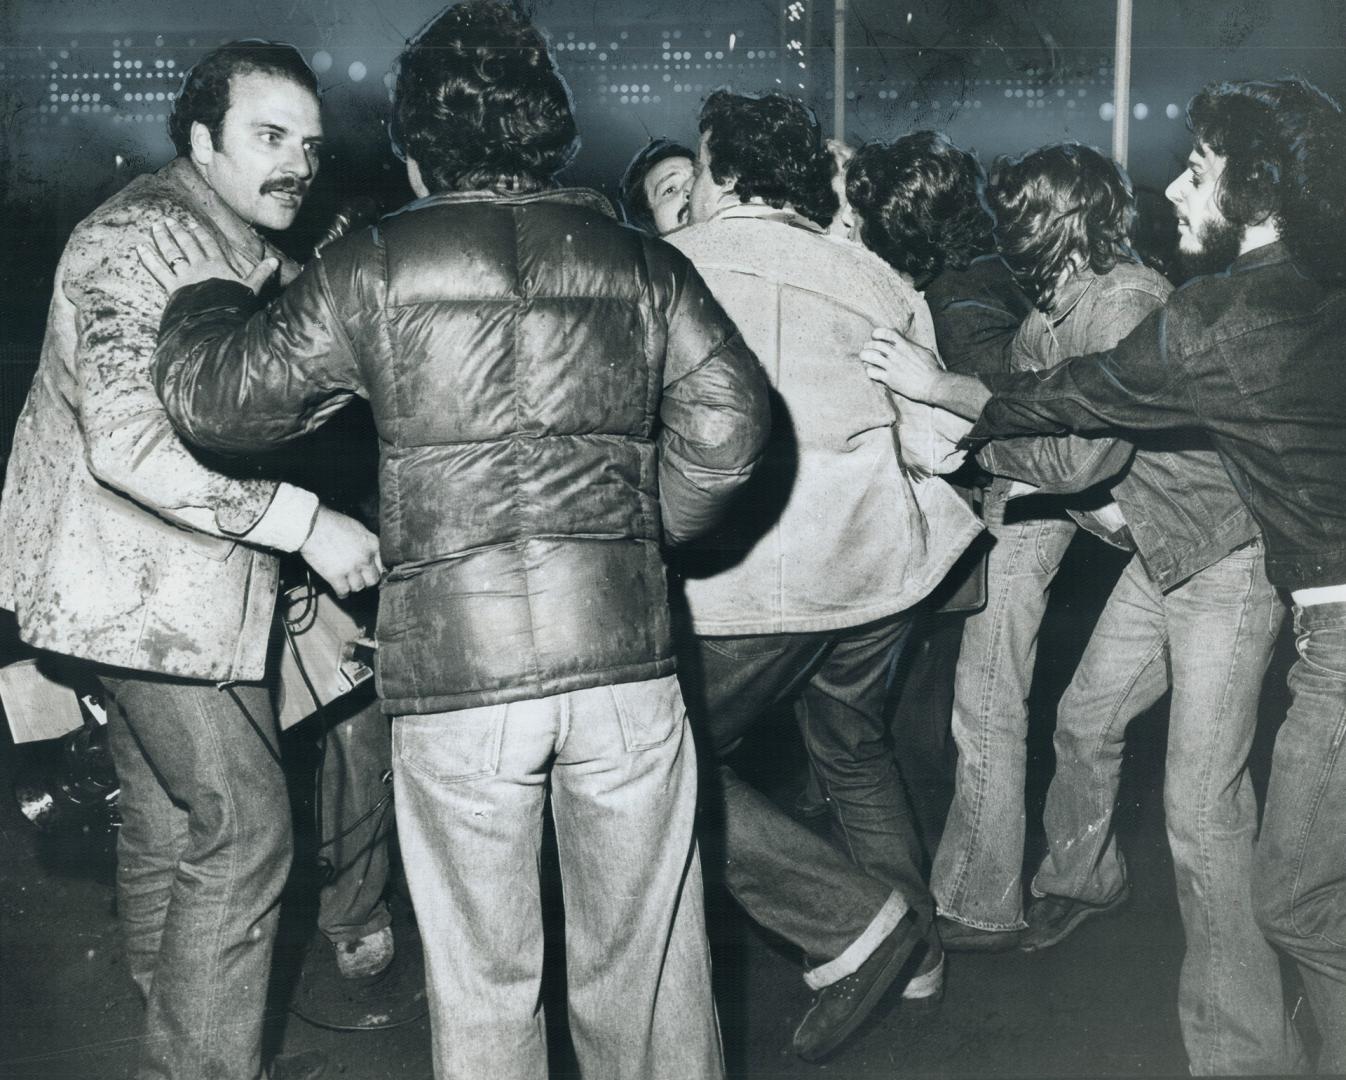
[68,207,318,551]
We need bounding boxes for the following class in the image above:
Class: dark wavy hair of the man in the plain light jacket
[699,90,840,226]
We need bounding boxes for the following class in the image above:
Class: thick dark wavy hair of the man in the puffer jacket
[389,0,579,191]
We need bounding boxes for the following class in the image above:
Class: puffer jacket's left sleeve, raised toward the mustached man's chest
[155,256,363,452]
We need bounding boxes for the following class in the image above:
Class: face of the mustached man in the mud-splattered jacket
[191,71,323,229]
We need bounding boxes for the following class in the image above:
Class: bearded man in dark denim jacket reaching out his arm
[875,78,1346,1072]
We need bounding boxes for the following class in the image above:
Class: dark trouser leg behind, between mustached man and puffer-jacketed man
[318,685,393,944]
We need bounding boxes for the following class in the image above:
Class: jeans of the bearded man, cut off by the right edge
[1253,603,1346,1073]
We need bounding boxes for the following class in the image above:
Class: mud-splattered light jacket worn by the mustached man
[0,158,318,681]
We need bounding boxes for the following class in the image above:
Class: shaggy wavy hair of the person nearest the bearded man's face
[987,143,1140,311]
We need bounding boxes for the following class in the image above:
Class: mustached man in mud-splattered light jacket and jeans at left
[0,42,381,1080]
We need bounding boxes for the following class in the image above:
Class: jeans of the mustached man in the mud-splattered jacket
[100,671,292,1080]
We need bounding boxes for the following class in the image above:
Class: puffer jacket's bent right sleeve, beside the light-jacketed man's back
[660,248,771,544]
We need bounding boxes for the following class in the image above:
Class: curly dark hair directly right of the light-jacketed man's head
[845,131,995,290]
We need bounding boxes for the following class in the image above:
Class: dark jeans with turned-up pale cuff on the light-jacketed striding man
[678,614,933,990]
